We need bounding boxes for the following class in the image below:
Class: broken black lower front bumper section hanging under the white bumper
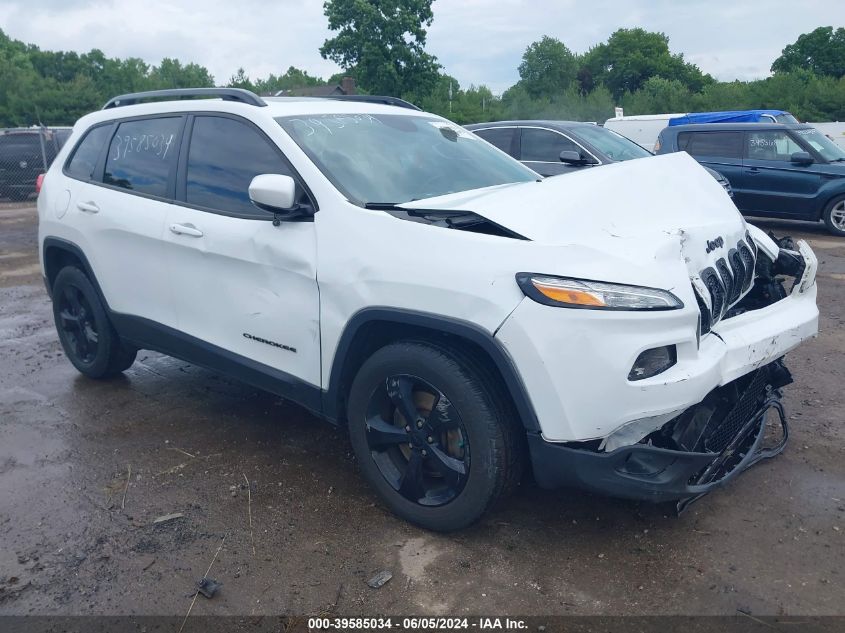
[528,360,792,512]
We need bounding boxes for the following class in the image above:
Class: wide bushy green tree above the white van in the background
[579,28,713,99]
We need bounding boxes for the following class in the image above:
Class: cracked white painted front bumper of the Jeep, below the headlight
[496,239,819,443]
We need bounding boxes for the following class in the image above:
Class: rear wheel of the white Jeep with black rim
[52,266,138,378]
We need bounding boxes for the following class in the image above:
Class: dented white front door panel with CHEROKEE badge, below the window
[165,207,320,386]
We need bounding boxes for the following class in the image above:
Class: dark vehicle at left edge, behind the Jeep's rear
[0,128,71,200]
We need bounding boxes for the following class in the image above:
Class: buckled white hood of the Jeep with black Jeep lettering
[401,152,747,286]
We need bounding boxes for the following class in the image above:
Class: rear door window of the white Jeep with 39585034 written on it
[103,117,182,197]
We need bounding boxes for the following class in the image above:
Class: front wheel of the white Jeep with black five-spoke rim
[347,342,522,532]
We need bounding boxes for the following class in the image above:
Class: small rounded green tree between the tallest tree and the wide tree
[519,35,578,98]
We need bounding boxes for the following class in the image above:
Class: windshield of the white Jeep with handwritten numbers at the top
[276,114,539,204]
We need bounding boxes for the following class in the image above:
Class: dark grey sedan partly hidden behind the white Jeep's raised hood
[464,120,731,195]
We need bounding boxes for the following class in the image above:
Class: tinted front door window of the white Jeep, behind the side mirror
[185,116,293,214]
